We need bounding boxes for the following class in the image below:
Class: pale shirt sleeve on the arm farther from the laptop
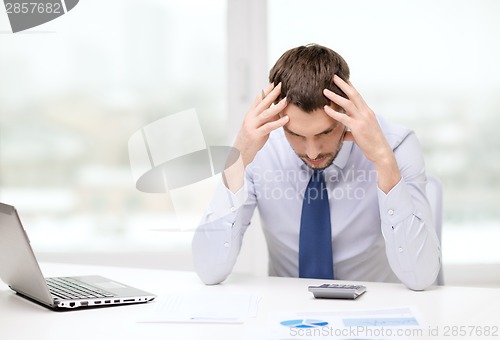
[378,134,441,290]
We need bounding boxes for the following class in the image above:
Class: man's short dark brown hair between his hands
[269,44,349,112]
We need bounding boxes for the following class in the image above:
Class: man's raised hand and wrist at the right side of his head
[323,75,401,193]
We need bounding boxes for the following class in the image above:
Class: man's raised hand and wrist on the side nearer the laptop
[223,83,289,193]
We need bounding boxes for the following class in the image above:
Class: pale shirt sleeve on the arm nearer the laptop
[192,175,253,284]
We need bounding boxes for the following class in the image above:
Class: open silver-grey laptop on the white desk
[0,203,156,310]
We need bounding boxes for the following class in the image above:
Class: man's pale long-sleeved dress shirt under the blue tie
[192,117,441,290]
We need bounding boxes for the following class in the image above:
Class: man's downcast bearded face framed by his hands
[281,104,345,170]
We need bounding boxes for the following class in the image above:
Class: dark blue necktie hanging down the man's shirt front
[299,170,333,279]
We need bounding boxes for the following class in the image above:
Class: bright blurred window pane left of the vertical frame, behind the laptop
[0,0,226,258]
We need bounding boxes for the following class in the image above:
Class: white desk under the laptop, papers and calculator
[0,264,500,340]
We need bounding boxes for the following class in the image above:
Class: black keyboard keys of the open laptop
[45,277,114,300]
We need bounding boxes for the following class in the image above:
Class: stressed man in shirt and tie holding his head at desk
[192,45,441,290]
